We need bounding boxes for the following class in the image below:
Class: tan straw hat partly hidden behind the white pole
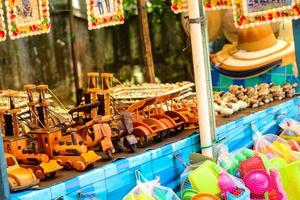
[181,10,223,40]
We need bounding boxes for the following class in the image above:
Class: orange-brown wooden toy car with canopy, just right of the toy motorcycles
[126,98,169,147]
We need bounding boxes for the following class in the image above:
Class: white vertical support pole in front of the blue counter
[188,0,215,157]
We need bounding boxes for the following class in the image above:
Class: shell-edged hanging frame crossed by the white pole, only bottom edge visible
[171,0,232,14]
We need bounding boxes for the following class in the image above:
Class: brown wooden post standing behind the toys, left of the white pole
[137,0,155,83]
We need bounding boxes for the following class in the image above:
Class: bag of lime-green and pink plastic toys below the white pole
[182,160,250,200]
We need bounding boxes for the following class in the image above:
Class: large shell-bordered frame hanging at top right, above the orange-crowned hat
[233,0,300,28]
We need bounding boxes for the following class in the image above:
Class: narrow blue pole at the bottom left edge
[0,133,10,200]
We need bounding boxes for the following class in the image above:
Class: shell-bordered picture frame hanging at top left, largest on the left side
[6,0,51,40]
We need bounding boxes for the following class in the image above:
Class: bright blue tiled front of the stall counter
[12,98,300,200]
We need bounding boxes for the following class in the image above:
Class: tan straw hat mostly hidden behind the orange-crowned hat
[222,9,280,44]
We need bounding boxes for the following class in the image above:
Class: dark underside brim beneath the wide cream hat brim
[212,60,282,79]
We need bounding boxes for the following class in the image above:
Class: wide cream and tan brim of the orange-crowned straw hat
[212,40,295,72]
